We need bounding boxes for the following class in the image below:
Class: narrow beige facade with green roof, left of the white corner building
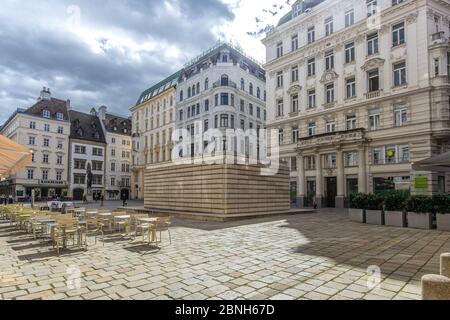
[130,72,180,200]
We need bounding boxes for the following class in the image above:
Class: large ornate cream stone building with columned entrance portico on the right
[263,0,450,207]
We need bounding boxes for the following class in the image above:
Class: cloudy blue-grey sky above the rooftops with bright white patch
[0,0,288,124]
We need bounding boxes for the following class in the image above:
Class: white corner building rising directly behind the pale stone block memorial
[176,43,267,157]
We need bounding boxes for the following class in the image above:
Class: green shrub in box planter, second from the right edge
[406,196,436,229]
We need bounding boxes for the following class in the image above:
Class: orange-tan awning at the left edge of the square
[0,135,32,179]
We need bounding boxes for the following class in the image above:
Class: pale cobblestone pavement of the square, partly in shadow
[0,211,450,300]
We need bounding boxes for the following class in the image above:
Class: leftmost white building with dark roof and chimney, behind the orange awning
[0,88,70,202]
